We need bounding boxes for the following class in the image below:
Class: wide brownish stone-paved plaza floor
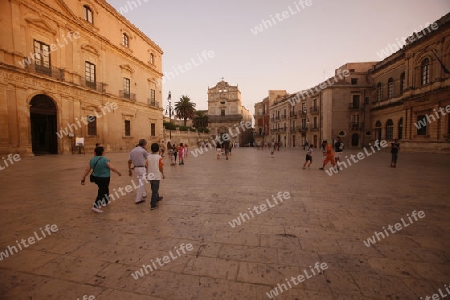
[0,148,450,300]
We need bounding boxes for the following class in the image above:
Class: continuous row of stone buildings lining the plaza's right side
[254,14,450,151]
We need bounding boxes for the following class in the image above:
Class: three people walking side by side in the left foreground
[81,139,165,213]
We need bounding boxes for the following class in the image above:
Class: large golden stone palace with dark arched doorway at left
[0,0,163,155]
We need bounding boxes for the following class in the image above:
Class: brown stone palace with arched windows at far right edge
[371,14,450,151]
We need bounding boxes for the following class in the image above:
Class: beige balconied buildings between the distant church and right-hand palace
[255,62,375,148]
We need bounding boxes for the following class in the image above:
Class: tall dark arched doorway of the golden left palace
[30,94,58,155]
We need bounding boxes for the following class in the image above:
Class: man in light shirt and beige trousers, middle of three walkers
[128,139,148,204]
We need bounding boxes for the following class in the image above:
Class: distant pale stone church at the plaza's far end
[208,80,253,145]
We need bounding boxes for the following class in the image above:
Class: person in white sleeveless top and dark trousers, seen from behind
[147,143,166,210]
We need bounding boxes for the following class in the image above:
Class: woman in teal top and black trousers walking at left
[81,147,122,213]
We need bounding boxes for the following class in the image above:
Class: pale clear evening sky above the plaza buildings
[107,0,450,114]
